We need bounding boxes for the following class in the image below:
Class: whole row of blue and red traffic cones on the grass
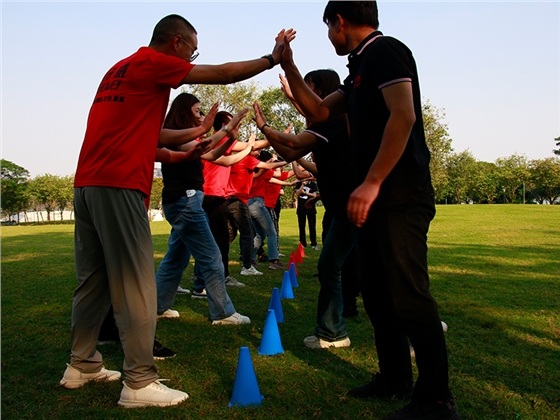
[228,244,305,407]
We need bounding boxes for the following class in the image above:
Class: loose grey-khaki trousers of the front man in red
[71,187,158,389]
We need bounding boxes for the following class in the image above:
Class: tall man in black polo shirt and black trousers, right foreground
[282,1,460,420]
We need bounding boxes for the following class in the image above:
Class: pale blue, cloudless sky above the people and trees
[1,0,560,177]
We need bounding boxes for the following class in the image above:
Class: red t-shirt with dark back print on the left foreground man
[74,47,194,196]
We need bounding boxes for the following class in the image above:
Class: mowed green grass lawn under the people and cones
[1,205,560,419]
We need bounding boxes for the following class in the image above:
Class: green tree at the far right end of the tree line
[529,157,560,204]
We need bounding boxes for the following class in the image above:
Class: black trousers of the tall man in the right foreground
[356,194,449,401]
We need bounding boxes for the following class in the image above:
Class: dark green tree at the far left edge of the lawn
[0,159,29,222]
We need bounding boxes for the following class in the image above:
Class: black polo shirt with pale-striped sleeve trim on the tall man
[341,31,433,207]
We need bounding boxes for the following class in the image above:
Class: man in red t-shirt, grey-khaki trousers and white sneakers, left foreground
[60,15,295,407]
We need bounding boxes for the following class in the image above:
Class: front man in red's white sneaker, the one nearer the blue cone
[118,380,189,408]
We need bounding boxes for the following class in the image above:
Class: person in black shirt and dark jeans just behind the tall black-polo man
[254,70,355,349]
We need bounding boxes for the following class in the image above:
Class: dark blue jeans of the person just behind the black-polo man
[315,218,354,341]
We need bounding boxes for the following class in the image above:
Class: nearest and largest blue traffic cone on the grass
[228,347,264,407]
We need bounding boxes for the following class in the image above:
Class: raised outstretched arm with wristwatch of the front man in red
[181,29,296,85]
